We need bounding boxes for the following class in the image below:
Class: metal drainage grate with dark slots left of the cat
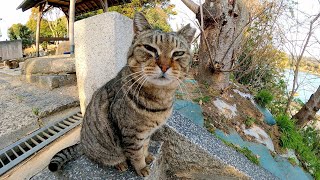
[0,112,82,175]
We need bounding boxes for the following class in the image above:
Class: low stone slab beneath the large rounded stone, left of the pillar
[21,74,77,90]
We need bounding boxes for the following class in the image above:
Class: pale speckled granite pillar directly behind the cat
[75,12,133,114]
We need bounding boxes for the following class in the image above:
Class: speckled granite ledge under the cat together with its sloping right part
[28,112,277,180]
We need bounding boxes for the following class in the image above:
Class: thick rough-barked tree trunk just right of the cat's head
[197,0,249,90]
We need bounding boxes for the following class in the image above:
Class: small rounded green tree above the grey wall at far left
[8,23,32,49]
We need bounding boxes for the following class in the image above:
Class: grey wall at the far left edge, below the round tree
[0,40,22,60]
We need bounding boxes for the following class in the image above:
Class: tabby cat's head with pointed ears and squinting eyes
[128,13,196,86]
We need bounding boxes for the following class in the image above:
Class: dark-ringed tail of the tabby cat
[48,144,83,172]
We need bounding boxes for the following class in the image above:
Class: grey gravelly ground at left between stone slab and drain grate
[0,68,79,149]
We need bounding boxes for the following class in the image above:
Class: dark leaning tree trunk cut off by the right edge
[292,86,320,128]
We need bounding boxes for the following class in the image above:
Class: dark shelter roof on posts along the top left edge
[17,0,131,16]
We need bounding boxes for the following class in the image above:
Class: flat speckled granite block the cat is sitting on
[31,141,163,180]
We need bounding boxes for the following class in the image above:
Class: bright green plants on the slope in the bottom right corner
[276,115,320,179]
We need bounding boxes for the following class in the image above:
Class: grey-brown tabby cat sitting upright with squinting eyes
[49,13,196,176]
